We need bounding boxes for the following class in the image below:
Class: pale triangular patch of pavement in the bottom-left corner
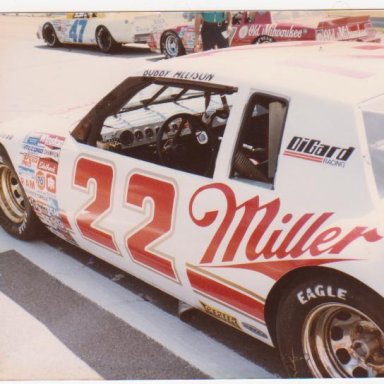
[0,292,102,380]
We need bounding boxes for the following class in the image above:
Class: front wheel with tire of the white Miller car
[0,149,45,240]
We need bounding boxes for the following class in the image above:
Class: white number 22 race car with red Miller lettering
[0,42,384,377]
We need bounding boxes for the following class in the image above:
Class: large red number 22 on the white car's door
[73,157,178,282]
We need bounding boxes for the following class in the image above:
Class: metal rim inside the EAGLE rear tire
[302,303,384,378]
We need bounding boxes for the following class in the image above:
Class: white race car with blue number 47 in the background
[37,12,187,53]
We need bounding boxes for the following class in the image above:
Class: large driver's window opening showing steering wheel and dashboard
[73,78,237,177]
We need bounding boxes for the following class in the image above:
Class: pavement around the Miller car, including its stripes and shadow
[0,16,285,380]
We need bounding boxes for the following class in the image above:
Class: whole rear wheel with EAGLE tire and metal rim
[276,271,384,378]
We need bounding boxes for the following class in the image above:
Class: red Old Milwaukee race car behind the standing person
[148,11,381,58]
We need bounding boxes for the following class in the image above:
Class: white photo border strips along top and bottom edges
[0,0,384,384]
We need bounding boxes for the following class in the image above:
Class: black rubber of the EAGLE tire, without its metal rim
[276,272,384,378]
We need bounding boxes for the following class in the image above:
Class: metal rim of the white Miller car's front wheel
[0,164,25,224]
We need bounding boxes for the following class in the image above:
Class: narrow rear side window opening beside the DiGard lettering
[230,94,288,185]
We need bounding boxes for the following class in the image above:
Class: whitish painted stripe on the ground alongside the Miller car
[0,229,277,379]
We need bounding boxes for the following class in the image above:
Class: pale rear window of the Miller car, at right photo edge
[362,96,384,197]
